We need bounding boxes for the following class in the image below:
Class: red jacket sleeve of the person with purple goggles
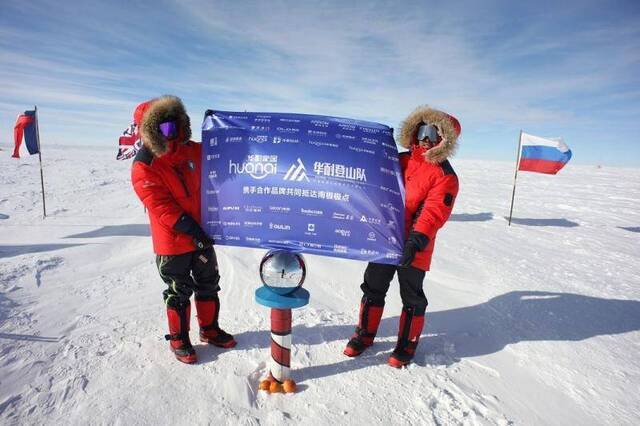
[131,161,184,228]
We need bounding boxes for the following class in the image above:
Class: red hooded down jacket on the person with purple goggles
[131,96,201,255]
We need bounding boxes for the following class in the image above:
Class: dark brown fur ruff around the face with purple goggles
[139,95,191,157]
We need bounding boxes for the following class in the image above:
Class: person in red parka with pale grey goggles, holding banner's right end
[344,106,460,368]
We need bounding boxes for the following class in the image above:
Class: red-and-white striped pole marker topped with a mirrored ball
[255,250,309,393]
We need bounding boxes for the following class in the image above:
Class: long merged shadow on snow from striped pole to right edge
[237,291,640,380]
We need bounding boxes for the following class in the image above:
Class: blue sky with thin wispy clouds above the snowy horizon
[0,0,640,167]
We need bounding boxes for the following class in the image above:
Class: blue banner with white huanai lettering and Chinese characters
[202,111,404,264]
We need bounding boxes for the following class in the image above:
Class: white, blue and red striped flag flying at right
[518,132,571,175]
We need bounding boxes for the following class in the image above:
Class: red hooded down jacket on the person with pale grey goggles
[400,106,460,271]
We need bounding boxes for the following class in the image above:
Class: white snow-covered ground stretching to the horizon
[0,148,640,425]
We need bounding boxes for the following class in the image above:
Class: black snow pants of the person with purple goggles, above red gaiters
[156,247,220,308]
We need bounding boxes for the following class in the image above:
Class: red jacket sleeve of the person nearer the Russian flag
[413,174,458,241]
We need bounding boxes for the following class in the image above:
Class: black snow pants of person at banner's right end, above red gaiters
[360,262,429,315]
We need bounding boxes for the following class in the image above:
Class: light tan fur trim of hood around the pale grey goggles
[399,105,461,164]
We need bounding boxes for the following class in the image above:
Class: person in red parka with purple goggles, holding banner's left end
[131,96,236,364]
